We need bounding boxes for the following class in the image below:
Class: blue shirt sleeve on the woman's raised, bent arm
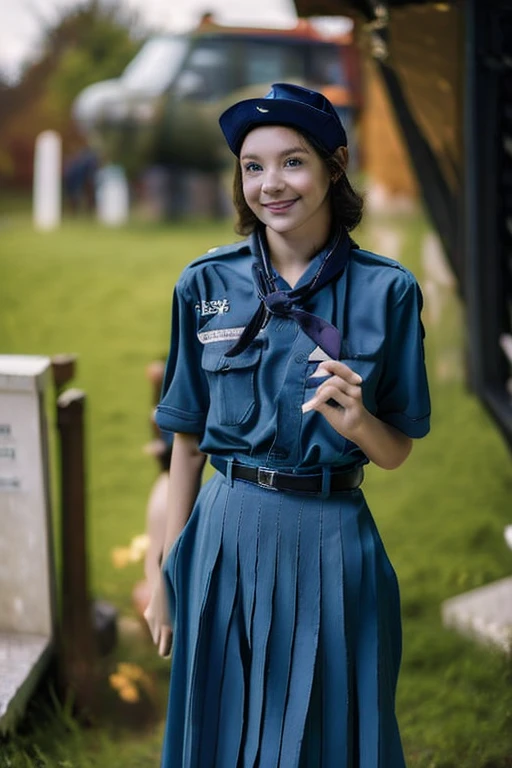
[376,276,430,437]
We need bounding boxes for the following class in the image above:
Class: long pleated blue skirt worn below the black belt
[162,473,405,768]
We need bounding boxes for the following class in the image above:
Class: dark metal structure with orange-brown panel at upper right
[295,0,512,447]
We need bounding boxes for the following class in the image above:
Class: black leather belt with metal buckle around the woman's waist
[211,456,364,494]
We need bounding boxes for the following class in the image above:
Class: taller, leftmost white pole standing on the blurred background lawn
[33,131,62,230]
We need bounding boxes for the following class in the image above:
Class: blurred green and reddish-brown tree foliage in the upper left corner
[0,0,146,186]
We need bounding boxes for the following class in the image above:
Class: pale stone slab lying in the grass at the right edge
[441,577,512,654]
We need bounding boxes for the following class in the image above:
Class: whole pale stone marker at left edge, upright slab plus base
[0,355,55,732]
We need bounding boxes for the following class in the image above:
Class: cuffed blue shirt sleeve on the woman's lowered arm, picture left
[155,282,209,434]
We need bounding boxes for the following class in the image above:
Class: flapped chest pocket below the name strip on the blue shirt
[202,342,261,426]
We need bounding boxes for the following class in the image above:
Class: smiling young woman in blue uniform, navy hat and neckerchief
[146,83,429,768]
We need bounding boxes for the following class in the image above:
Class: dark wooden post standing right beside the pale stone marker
[57,389,96,715]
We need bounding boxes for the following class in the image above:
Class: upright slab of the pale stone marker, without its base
[0,355,54,635]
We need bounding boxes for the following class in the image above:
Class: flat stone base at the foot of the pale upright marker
[0,632,52,733]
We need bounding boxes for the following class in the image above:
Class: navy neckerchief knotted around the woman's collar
[225,227,358,360]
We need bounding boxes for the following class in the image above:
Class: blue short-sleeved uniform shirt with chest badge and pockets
[156,240,430,472]
